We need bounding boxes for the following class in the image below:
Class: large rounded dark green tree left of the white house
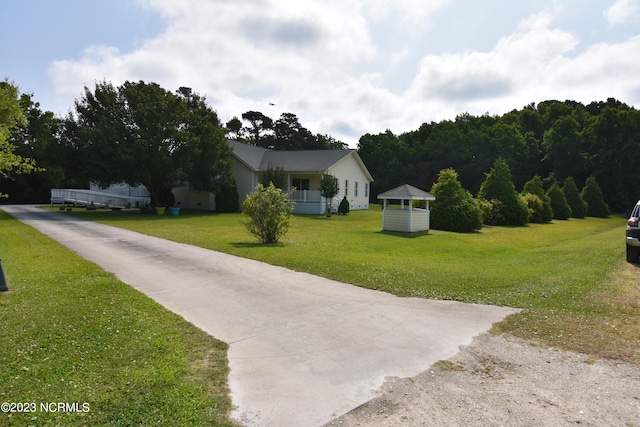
[67,81,232,206]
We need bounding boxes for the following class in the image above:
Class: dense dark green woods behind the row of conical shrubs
[358,98,640,212]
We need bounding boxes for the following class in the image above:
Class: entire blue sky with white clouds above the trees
[0,0,640,148]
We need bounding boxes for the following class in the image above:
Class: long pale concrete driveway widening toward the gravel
[2,206,517,427]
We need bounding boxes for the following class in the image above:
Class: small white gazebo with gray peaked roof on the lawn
[378,184,436,233]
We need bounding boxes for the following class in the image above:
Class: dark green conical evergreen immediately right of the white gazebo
[431,169,482,232]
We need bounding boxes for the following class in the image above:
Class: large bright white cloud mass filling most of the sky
[49,0,640,146]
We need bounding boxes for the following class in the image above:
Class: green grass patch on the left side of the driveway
[0,211,232,426]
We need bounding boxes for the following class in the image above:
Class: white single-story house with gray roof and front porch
[230,141,373,214]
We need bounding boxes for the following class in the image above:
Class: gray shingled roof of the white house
[229,141,373,181]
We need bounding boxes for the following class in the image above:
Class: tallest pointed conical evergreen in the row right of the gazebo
[478,159,529,225]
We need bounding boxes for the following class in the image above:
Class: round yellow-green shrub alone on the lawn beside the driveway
[242,183,295,243]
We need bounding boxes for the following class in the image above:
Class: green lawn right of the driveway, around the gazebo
[57,207,640,365]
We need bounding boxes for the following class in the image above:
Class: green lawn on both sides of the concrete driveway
[0,207,640,426]
